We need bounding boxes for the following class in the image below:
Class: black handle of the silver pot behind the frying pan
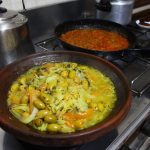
[95,0,111,12]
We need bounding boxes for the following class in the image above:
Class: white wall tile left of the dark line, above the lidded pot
[1,0,23,11]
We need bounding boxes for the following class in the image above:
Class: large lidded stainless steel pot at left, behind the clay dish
[0,1,34,68]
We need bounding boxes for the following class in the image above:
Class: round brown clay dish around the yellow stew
[0,51,131,147]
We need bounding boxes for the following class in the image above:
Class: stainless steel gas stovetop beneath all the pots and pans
[0,22,150,150]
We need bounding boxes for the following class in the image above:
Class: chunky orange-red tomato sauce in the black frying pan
[60,29,129,51]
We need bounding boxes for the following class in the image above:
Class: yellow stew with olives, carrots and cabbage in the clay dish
[7,62,117,133]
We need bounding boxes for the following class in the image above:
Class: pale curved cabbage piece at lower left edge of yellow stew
[10,104,38,124]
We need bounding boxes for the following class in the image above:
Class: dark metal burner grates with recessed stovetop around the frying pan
[35,25,150,96]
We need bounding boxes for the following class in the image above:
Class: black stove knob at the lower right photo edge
[141,117,150,137]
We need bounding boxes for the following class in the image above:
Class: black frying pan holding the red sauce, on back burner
[55,19,145,54]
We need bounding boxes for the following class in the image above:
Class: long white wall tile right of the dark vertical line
[24,0,75,9]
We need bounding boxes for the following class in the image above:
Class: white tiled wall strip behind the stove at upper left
[2,0,75,11]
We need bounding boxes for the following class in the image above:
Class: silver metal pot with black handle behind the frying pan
[96,0,134,25]
